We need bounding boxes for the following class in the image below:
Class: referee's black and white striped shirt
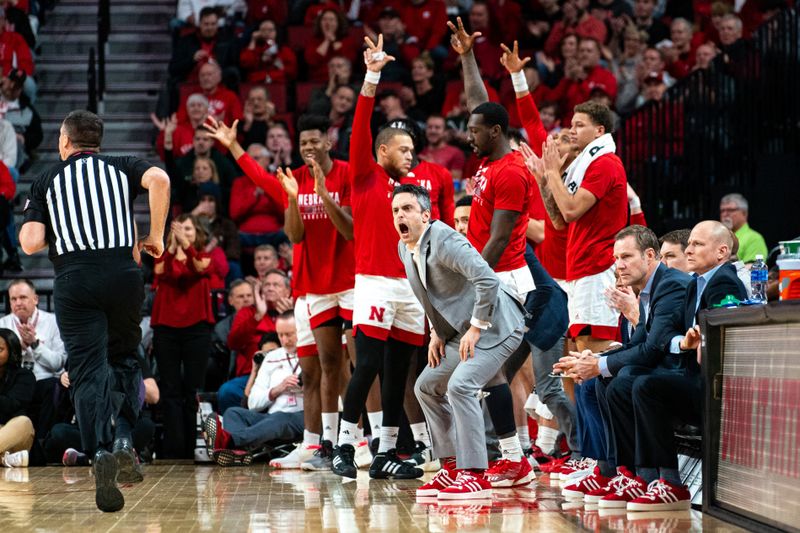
[24,152,152,260]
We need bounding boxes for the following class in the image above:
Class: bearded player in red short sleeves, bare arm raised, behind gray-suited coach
[448,18,535,487]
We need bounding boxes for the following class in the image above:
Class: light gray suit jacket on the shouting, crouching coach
[398,220,524,349]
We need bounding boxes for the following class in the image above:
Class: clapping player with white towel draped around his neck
[528,102,628,353]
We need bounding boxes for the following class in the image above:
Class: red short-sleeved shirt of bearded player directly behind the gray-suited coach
[467,152,531,272]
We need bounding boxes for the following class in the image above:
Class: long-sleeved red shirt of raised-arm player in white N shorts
[350,95,415,278]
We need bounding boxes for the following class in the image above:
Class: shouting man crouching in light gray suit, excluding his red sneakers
[392,185,523,470]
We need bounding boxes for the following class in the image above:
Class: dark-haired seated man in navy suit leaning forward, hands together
[556,226,690,503]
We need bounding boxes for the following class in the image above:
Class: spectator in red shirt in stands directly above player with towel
[551,39,617,124]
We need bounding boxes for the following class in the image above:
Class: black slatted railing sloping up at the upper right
[618,4,800,243]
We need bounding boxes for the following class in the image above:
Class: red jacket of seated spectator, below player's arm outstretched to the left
[230,169,283,233]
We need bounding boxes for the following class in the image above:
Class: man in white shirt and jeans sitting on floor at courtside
[203,311,303,466]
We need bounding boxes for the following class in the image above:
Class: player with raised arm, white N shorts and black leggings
[332,35,425,479]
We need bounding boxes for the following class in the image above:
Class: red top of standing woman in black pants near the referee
[150,247,214,328]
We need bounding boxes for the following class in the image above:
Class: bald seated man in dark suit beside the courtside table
[599,221,747,511]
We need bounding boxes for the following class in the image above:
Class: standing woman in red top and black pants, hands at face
[150,214,214,459]
